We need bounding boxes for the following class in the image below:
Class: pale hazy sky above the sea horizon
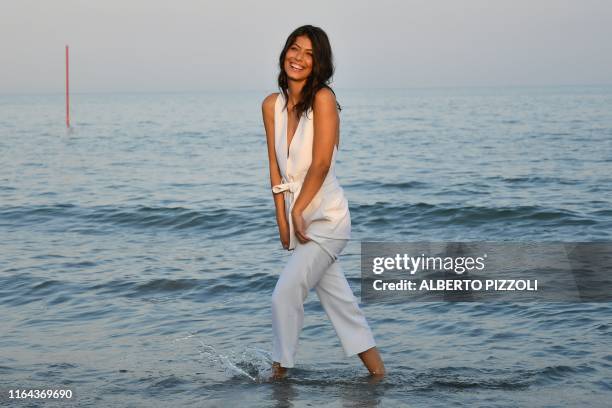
[0,0,612,93]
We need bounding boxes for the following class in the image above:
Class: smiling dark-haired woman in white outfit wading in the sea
[262,25,385,378]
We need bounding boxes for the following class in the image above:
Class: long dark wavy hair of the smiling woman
[278,25,342,118]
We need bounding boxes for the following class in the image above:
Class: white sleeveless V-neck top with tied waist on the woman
[272,92,351,249]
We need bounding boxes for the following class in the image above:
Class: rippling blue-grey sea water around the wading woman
[0,86,612,407]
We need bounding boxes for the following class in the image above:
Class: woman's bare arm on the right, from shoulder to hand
[291,88,340,241]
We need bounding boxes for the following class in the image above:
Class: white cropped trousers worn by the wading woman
[272,236,376,367]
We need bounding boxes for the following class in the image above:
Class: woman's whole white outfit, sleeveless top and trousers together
[272,93,376,367]
